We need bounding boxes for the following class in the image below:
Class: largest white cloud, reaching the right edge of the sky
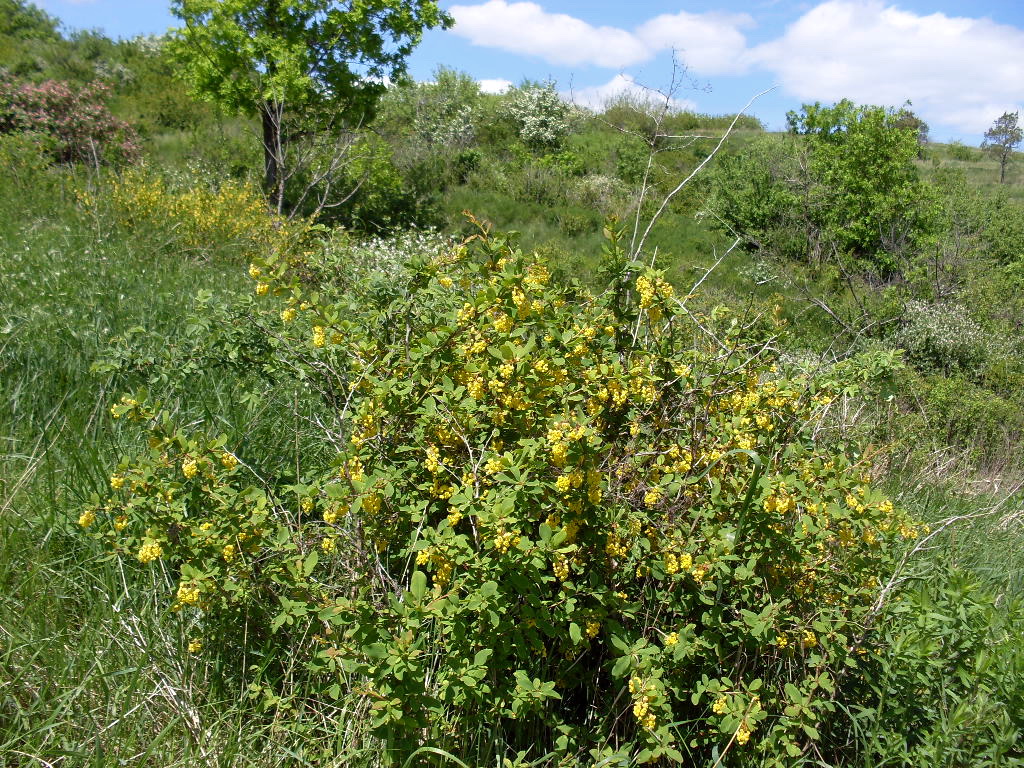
[745,0,1024,134]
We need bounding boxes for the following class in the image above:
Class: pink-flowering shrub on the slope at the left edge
[0,76,138,163]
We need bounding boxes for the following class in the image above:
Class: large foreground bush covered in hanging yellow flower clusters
[80,219,921,765]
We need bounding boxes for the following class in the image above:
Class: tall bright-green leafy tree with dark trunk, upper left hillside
[171,0,452,211]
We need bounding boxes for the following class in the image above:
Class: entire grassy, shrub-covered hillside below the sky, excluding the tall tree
[0,0,1024,767]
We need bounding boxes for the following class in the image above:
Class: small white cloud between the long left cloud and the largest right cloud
[637,11,754,75]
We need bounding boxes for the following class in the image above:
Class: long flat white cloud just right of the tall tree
[449,0,653,69]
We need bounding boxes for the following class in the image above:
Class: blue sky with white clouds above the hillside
[37,0,1024,143]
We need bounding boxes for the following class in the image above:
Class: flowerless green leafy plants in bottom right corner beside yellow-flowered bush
[853,567,1024,766]
